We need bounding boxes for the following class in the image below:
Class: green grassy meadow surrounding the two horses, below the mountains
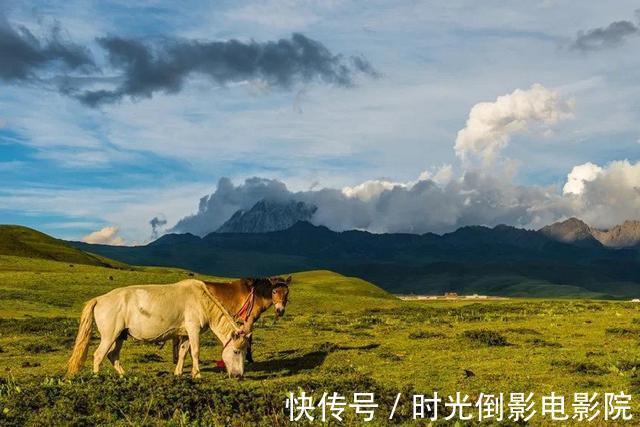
[0,256,640,425]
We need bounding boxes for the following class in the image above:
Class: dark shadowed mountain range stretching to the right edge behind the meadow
[71,204,640,298]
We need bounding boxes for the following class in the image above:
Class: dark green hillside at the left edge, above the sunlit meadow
[0,225,126,267]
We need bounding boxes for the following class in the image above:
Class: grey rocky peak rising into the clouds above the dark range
[216,200,317,233]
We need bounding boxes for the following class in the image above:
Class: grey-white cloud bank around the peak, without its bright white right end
[173,168,570,235]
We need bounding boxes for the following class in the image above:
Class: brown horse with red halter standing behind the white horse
[173,276,291,365]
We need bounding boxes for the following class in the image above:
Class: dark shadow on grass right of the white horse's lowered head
[202,343,380,380]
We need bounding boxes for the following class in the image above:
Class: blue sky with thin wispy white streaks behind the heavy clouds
[0,0,640,243]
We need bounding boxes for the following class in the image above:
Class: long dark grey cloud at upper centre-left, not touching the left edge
[75,34,377,106]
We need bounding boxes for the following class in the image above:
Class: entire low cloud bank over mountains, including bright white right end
[172,160,640,235]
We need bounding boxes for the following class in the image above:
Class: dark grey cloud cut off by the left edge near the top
[0,16,93,81]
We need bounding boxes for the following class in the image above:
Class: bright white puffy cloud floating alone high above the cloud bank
[454,83,573,163]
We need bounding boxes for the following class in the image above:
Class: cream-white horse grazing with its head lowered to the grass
[67,280,251,378]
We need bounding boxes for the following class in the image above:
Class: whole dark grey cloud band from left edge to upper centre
[0,12,378,107]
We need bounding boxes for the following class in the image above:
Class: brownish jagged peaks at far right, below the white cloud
[538,218,640,248]
